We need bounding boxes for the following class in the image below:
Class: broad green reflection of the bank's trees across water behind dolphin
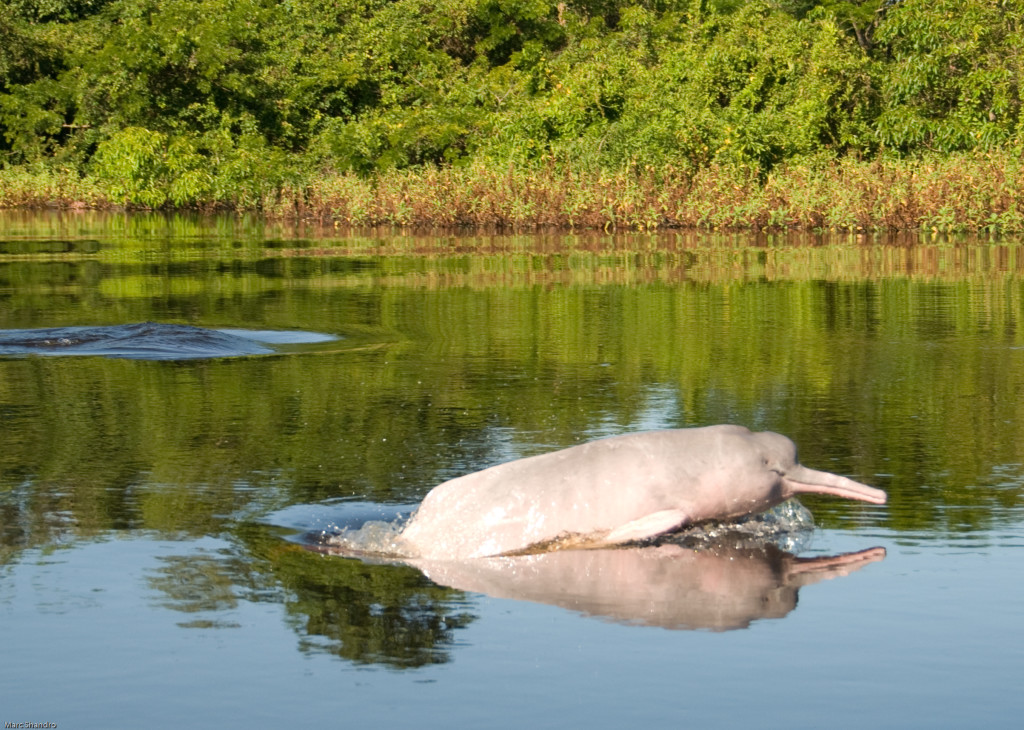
[0,234,1024,560]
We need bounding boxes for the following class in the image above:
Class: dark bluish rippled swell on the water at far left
[0,321,336,360]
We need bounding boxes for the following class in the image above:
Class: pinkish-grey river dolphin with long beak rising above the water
[395,426,886,560]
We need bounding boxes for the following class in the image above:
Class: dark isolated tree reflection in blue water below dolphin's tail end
[150,525,474,668]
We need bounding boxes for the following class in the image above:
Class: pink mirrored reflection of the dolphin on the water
[314,544,886,631]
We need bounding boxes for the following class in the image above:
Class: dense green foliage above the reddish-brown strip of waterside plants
[0,0,1024,207]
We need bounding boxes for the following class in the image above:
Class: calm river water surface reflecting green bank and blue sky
[0,213,1024,728]
